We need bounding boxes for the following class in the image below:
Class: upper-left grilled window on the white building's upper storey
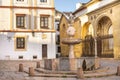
[16,15,25,28]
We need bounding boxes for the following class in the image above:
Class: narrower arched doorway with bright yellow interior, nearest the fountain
[82,22,94,57]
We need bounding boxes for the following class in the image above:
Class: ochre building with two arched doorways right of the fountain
[60,0,120,59]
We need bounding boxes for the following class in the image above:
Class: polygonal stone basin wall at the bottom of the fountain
[44,57,100,71]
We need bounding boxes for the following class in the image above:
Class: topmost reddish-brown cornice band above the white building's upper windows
[0,6,55,10]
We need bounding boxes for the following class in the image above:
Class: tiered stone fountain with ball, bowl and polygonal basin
[44,15,99,71]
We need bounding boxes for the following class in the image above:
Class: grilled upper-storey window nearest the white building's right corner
[40,16,49,29]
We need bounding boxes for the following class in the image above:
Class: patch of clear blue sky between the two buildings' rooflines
[54,0,90,12]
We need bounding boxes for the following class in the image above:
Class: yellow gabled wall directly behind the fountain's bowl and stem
[60,16,82,58]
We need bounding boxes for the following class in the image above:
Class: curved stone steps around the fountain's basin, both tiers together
[24,68,116,78]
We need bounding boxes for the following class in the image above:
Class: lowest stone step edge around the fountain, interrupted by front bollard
[24,71,116,78]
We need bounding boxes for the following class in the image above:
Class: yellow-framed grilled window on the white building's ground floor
[16,37,25,49]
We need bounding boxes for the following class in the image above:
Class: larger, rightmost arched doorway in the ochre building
[97,16,114,57]
